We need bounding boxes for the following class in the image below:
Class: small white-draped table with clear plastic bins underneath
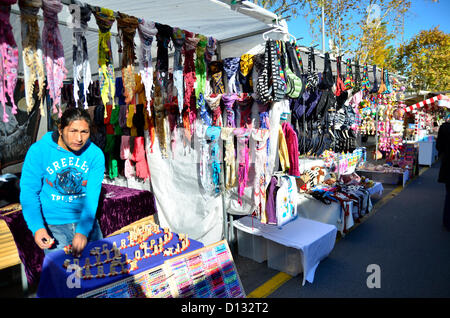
[233,216,337,285]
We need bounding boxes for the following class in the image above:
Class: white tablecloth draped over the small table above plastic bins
[233,216,337,285]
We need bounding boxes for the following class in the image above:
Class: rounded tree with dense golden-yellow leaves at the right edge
[395,27,450,91]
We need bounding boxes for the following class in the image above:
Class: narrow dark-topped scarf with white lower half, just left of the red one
[172,28,186,123]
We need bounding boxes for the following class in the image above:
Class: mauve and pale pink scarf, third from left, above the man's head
[42,0,67,117]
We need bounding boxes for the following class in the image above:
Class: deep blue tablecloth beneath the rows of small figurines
[37,226,203,298]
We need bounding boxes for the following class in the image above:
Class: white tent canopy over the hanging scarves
[10,0,277,78]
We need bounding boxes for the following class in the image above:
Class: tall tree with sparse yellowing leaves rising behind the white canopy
[254,0,411,59]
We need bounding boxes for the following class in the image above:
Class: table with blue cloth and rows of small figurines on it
[37,224,203,298]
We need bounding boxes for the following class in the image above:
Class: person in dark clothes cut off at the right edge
[436,120,450,231]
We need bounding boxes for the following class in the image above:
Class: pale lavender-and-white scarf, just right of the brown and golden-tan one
[138,19,158,115]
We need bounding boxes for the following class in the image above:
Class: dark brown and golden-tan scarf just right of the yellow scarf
[116,12,138,104]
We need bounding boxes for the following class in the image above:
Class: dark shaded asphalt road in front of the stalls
[235,163,450,298]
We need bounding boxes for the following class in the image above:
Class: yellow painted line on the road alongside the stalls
[247,167,430,298]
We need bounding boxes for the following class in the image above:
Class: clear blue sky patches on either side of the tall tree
[288,0,450,50]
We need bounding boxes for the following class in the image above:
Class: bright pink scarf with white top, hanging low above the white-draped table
[234,128,251,206]
